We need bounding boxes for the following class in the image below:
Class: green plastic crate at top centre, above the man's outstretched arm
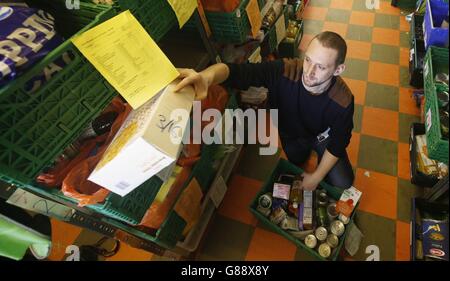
[205,0,251,44]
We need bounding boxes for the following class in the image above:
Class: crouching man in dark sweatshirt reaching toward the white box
[176,31,354,190]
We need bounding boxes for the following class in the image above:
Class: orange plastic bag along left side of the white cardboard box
[61,99,131,206]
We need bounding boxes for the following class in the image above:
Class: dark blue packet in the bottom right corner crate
[422,219,448,261]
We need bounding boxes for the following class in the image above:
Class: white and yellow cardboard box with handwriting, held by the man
[88,80,195,196]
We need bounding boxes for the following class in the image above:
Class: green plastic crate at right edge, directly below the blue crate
[423,46,449,164]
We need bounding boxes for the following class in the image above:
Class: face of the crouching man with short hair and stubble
[302,39,338,87]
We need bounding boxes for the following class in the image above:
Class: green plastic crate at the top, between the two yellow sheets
[115,0,178,42]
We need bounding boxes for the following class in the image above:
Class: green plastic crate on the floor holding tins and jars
[249,159,356,261]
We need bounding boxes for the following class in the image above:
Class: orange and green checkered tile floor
[51,0,422,261]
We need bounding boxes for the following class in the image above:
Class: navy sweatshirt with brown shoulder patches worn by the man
[224,60,354,158]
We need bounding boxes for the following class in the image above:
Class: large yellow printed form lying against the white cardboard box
[72,11,179,109]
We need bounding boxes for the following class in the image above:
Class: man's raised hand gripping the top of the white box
[174,68,209,100]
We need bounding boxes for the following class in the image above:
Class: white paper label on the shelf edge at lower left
[6,188,75,221]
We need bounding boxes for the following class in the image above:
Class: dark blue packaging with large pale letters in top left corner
[0,6,65,86]
